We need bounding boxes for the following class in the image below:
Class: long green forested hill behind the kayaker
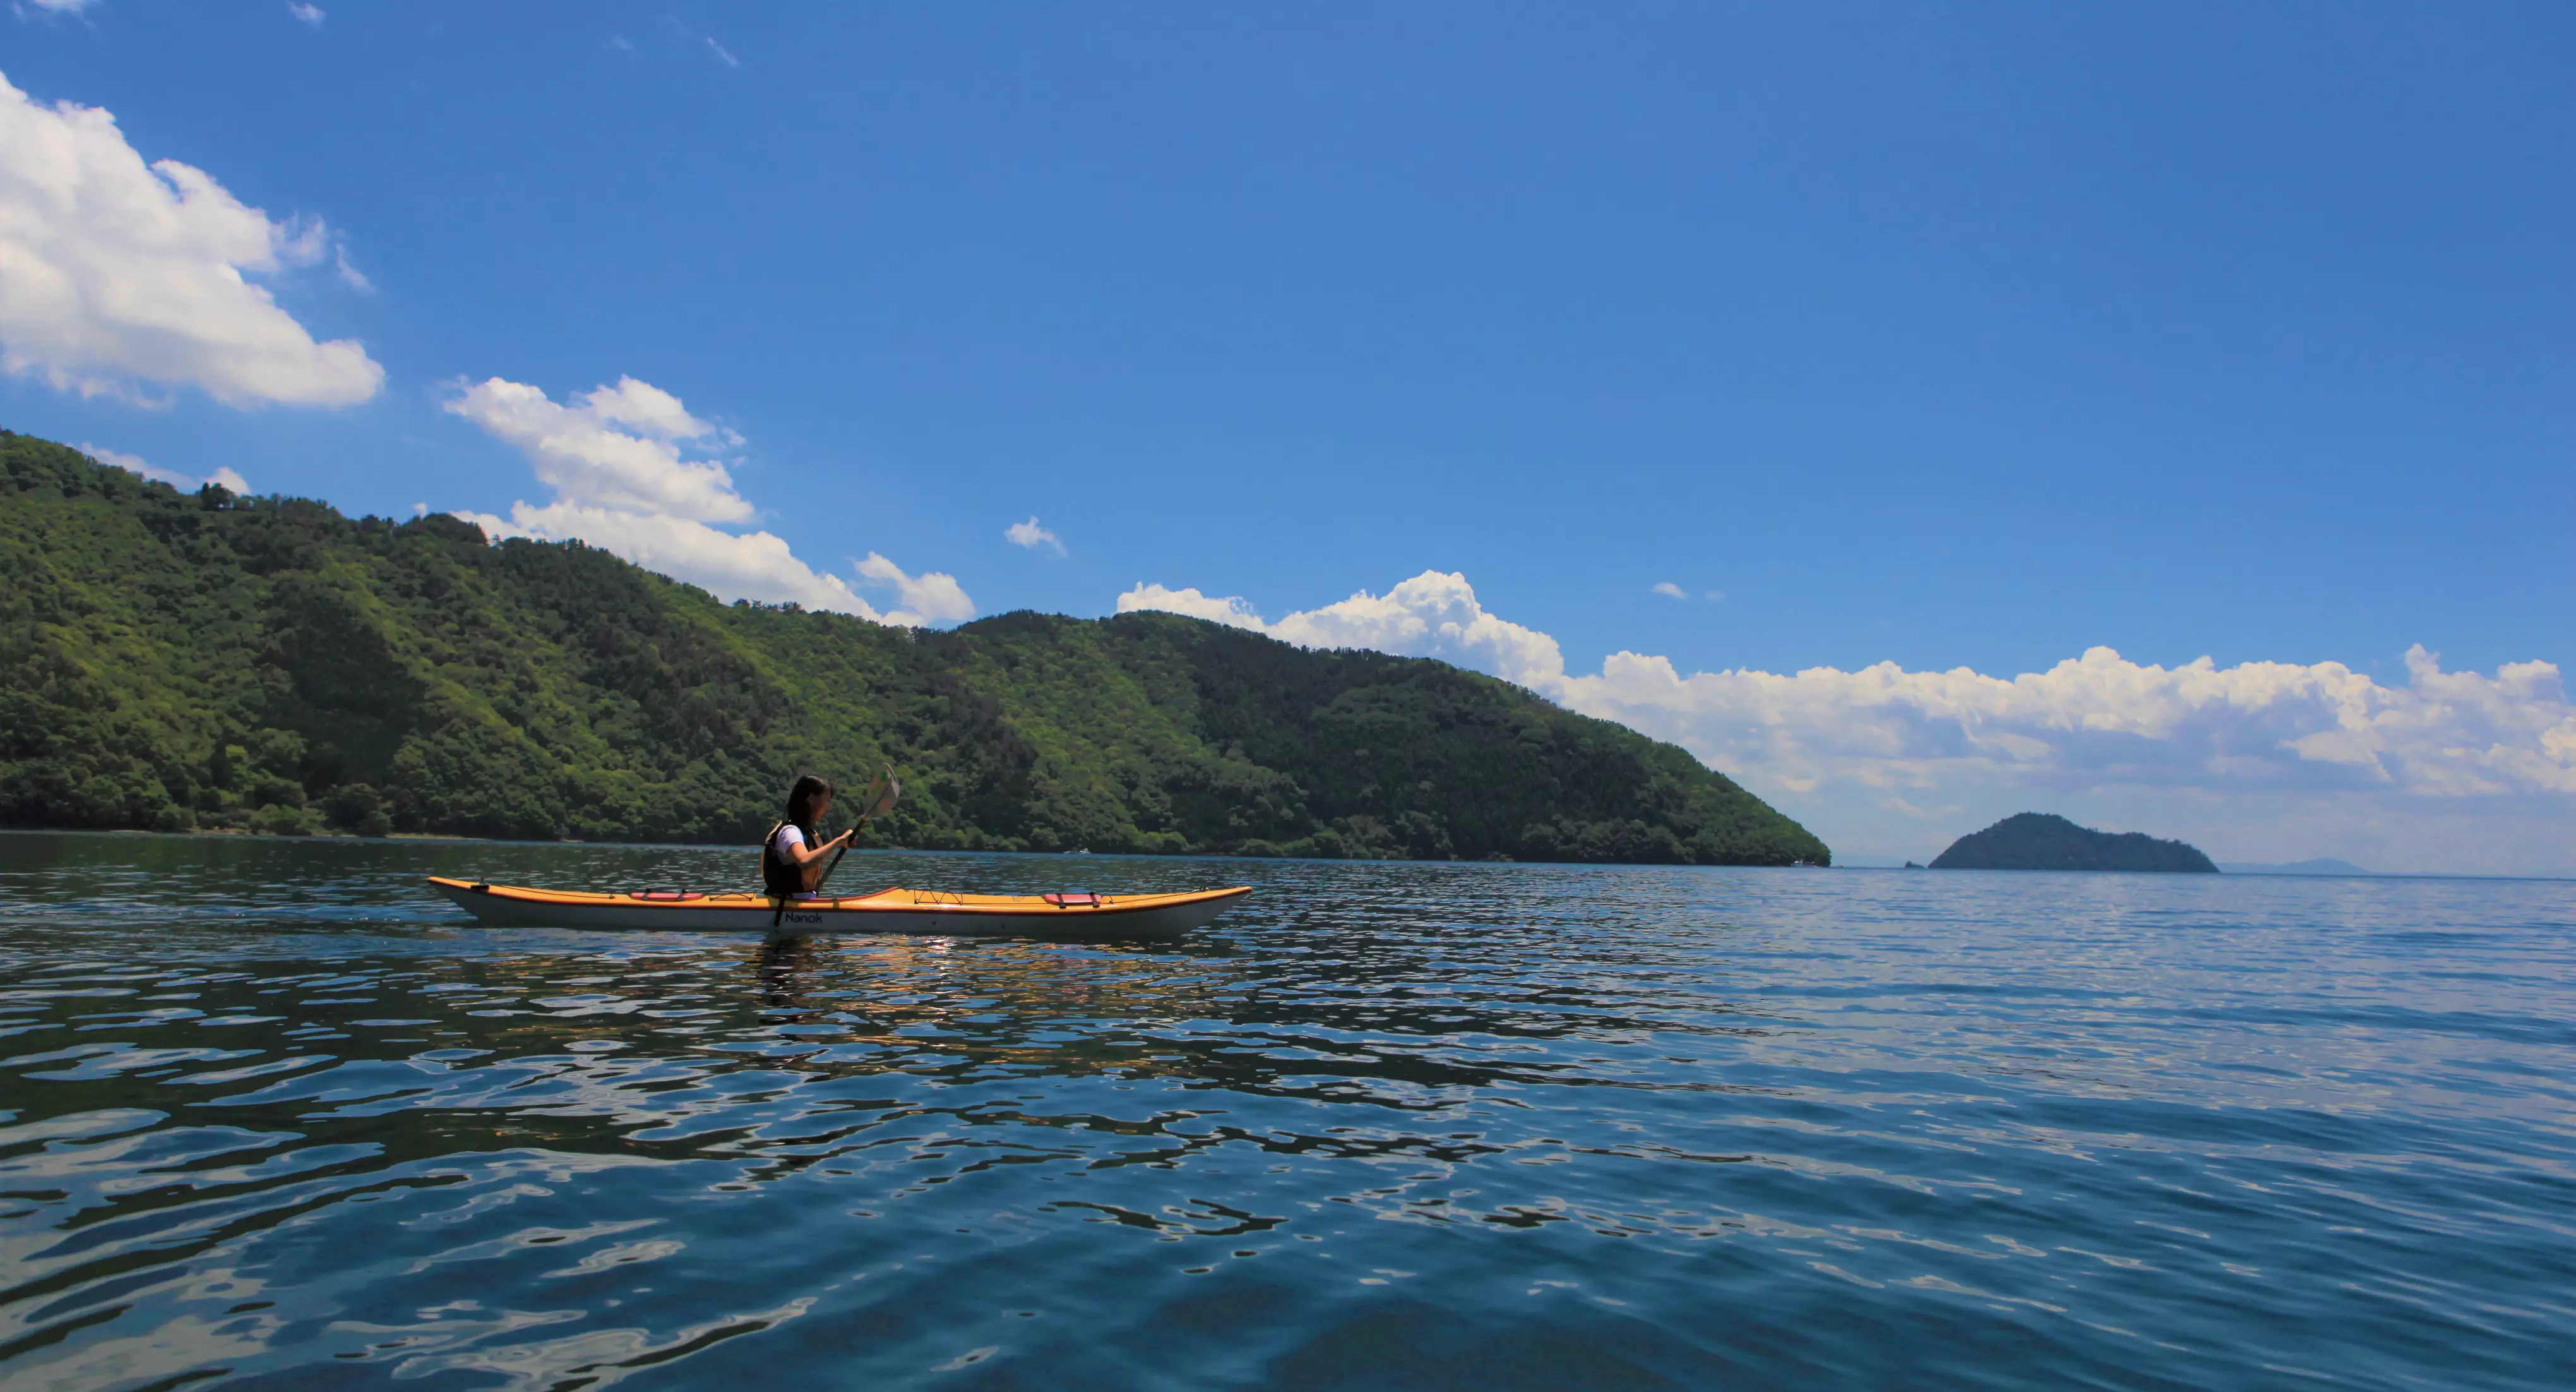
[0,431,1827,863]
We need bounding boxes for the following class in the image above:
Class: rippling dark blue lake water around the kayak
[0,835,2576,1392]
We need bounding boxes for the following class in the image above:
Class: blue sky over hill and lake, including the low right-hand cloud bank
[0,0,2576,872]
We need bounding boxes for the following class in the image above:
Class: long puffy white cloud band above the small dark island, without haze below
[1541,647,2576,796]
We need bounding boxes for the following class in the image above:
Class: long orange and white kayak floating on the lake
[430,874,1252,939]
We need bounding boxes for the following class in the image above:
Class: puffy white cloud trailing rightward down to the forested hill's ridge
[446,376,974,627]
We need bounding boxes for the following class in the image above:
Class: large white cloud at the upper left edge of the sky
[0,77,384,407]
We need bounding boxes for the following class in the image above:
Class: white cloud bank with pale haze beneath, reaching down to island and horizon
[1118,572,2576,872]
